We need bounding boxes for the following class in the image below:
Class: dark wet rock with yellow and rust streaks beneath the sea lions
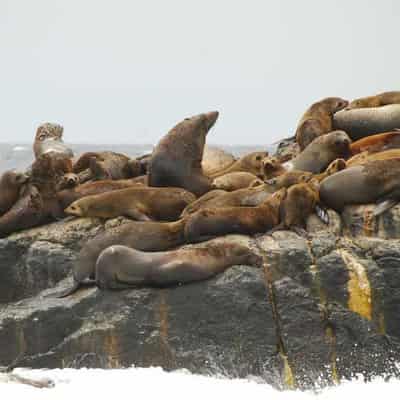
[0,205,400,388]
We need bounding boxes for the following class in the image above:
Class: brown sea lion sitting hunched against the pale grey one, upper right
[296,97,349,150]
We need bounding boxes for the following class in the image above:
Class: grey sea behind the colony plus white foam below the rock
[0,144,400,400]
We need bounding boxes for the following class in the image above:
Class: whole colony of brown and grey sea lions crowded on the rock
[0,92,400,296]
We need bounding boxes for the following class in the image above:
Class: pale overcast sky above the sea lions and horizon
[0,0,400,144]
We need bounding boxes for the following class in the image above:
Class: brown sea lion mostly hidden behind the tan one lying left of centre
[57,178,143,210]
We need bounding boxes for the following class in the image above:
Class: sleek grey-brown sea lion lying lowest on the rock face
[96,240,262,289]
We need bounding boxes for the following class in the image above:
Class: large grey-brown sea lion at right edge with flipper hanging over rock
[320,158,400,216]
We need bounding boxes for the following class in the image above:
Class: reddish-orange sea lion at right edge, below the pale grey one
[350,130,400,155]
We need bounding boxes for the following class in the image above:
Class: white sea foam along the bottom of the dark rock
[0,368,400,400]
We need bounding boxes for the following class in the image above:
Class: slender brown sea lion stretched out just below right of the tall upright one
[182,183,275,216]
